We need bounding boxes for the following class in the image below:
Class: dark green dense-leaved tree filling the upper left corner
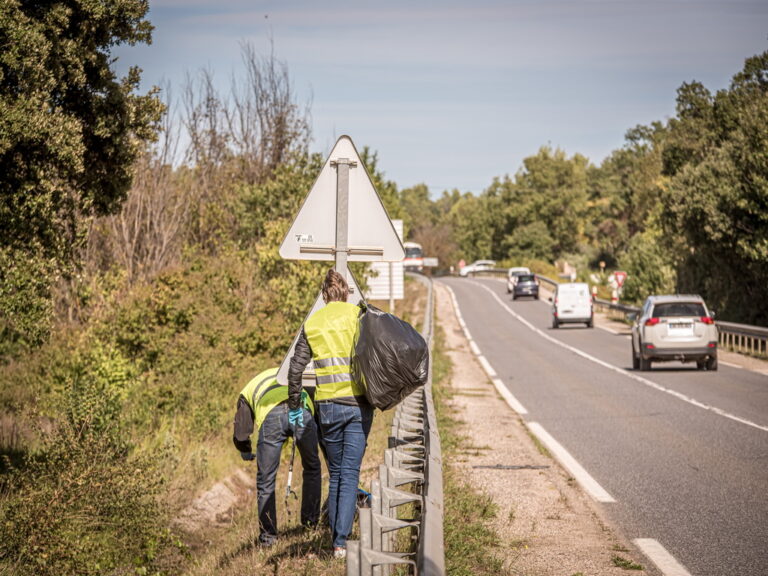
[0,0,162,342]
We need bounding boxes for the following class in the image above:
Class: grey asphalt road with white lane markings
[440,278,768,576]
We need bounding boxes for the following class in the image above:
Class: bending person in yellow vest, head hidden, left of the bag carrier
[232,368,321,546]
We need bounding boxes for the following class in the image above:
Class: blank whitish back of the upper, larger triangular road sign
[280,136,405,262]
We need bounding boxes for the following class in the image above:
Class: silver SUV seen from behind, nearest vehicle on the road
[632,294,718,370]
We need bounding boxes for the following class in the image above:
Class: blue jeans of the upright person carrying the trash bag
[317,402,373,547]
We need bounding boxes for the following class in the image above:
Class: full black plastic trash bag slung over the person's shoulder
[352,304,429,410]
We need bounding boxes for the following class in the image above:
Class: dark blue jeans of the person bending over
[256,402,321,544]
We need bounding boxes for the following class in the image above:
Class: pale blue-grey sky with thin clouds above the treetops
[115,0,768,195]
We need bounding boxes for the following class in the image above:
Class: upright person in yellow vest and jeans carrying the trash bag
[288,268,373,558]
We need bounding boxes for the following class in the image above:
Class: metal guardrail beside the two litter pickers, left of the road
[347,274,445,576]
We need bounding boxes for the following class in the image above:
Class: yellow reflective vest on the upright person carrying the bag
[304,302,365,402]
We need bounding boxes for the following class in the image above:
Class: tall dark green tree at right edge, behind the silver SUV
[663,52,768,324]
